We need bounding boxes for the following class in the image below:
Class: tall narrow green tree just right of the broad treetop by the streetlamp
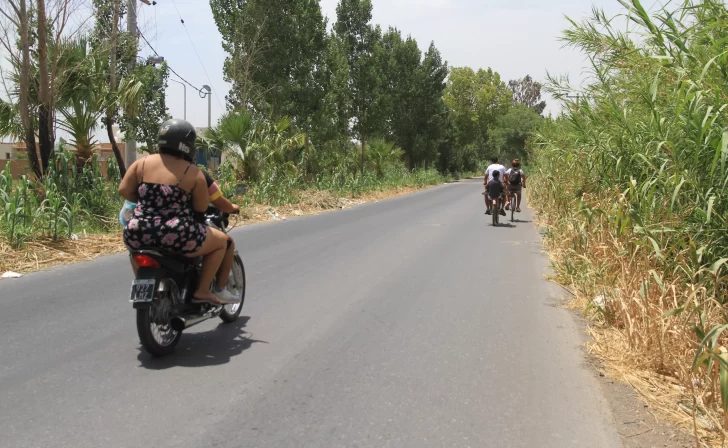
[334,0,383,174]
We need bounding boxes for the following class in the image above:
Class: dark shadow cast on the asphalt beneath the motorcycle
[137,316,267,370]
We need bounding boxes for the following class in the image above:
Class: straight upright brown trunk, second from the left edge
[37,0,55,173]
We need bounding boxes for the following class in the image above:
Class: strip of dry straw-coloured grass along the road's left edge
[0,183,427,274]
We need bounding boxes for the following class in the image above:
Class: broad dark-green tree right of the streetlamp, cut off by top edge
[210,0,326,172]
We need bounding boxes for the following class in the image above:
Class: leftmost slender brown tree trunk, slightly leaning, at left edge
[18,0,43,178]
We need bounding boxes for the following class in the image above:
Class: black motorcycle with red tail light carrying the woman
[129,186,245,357]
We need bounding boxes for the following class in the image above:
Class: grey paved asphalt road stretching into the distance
[0,181,619,448]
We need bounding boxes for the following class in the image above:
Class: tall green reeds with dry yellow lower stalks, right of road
[529,0,728,440]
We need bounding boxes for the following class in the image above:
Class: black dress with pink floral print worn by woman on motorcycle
[124,167,207,255]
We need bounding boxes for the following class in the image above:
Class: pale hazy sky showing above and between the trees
[1,0,622,141]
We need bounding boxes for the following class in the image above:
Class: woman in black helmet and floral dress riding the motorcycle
[119,119,240,305]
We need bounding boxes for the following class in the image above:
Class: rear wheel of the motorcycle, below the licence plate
[136,280,182,357]
